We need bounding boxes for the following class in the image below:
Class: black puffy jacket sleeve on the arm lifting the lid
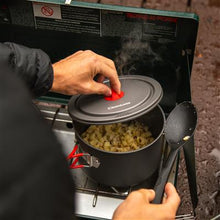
[0,42,53,97]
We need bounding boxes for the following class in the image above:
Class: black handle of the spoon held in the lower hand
[152,149,179,204]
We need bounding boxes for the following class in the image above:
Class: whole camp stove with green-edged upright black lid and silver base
[0,0,198,219]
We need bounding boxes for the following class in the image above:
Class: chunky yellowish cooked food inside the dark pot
[82,120,154,152]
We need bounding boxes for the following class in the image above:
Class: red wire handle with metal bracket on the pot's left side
[66,144,100,169]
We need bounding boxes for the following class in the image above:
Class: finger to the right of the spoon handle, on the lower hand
[163,183,180,211]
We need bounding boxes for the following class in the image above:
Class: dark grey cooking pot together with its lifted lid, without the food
[68,75,165,187]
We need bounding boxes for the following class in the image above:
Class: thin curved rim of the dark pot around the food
[75,105,166,155]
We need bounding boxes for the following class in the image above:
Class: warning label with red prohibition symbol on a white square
[33,2,101,35]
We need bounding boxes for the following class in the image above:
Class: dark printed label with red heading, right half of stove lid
[102,10,177,43]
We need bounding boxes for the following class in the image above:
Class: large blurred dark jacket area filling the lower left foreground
[0,65,75,220]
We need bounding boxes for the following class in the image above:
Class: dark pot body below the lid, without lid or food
[73,105,165,187]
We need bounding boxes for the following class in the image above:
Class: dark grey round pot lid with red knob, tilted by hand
[68,75,163,124]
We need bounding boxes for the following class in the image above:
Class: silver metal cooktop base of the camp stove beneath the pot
[37,102,177,219]
